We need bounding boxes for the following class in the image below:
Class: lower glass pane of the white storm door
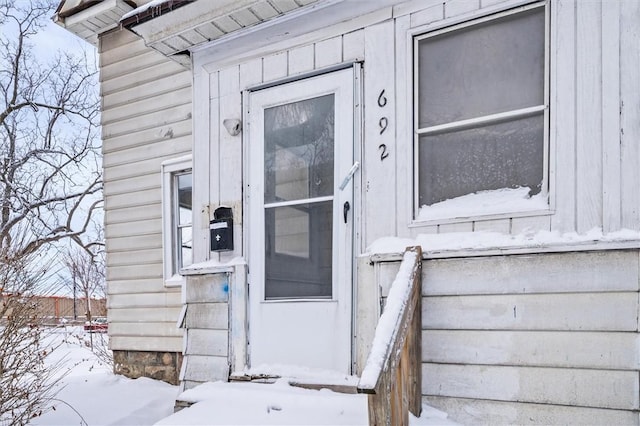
[265,201,333,299]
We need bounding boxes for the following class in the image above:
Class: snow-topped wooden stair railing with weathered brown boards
[358,247,422,426]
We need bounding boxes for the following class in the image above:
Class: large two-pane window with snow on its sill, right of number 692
[414,3,548,219]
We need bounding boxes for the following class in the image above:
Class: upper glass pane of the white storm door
[264,94,334,203]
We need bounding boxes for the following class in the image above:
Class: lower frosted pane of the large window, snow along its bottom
[419,114,544,206]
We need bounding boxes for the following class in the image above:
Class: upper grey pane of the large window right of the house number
[418,7,545,128]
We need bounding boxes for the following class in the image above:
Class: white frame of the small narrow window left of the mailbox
[161,155,193,287]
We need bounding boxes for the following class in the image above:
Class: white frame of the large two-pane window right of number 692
[407,0,553,226]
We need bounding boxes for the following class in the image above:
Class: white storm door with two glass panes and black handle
[248,69,354,373]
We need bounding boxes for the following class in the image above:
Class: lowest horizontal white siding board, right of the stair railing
[425,396,638,425]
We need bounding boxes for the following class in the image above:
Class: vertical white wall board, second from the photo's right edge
[601,1,625,232]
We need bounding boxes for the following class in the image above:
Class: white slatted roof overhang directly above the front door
[122,0,398,66]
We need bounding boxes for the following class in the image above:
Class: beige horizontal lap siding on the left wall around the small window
[100,27,191,352]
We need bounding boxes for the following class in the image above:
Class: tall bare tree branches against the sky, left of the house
[0,0,102,256]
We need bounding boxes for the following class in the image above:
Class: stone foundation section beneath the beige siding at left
[113,351,182,385]
